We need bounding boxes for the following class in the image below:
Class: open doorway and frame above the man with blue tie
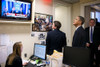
[81,1,100,28]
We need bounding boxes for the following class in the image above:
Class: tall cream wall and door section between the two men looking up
[54,1,72,46]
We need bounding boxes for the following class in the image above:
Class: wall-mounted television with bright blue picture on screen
[0,0,32,20]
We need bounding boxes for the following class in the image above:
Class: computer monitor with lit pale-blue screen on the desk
[34,43,46,60]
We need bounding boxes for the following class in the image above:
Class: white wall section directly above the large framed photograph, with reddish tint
[35,0,53,15]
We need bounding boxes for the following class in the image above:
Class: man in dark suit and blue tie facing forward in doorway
[85,19,100,67]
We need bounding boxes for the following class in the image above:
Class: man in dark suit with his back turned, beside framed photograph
[46,21,66,55]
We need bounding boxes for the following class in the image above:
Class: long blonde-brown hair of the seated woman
[7,42,22,65]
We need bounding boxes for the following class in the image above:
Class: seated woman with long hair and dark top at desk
[5,42,23,67]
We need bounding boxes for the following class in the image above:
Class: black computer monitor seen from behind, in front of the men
[63,46,91,67]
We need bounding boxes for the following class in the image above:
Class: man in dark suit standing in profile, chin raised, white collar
[72,16,86,47]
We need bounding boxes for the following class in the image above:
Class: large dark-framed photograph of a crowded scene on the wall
[32,13,53,31]
